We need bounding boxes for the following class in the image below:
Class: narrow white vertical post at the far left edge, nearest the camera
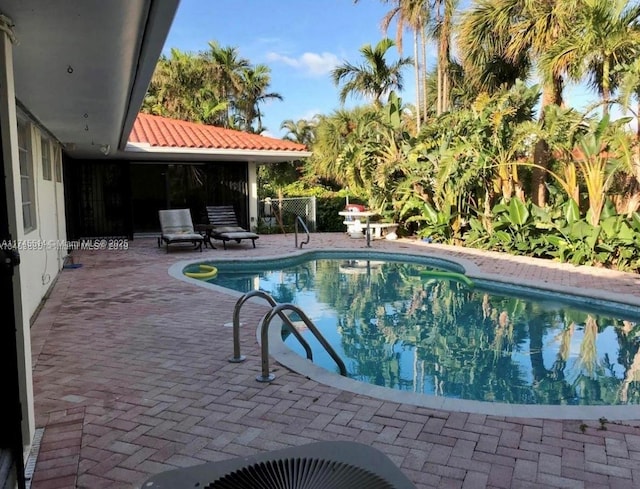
[0,16,35,447]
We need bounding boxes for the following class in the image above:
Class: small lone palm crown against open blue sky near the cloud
[331,38,412,107]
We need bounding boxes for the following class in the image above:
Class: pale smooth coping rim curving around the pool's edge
[168,248,640,421]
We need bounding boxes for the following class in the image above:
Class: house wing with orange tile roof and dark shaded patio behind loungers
[64,114,309,240]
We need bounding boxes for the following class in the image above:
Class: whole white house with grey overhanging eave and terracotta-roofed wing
[0,0,308,488]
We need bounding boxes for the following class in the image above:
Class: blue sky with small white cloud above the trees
[164,0,593,137]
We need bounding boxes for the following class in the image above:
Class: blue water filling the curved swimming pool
[186,253,640,405]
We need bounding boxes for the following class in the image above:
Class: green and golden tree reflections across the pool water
[317,263,640,404]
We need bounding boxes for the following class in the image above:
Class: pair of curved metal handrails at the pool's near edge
[229,290,347,382]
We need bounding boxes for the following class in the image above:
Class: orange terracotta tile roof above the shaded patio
[129,113,307,151]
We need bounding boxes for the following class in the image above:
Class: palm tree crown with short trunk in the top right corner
[541,0,640,116]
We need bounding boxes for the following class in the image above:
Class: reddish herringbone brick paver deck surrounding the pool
[32,234,640,489]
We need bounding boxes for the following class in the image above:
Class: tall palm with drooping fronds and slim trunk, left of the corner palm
[460,0,576,205]
